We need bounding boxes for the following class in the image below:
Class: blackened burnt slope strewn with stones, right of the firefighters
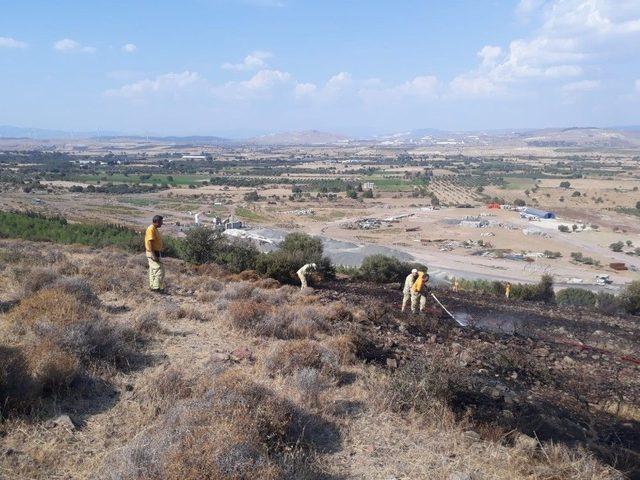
[318,281,640,479]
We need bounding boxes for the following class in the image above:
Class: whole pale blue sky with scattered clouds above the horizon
[0,0,640,136]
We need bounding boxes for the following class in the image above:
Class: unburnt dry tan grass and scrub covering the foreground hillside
[0,240,622,480]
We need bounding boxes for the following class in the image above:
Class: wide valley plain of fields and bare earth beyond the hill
[0,141,640,291]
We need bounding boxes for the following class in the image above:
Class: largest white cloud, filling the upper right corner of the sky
[450,0,640,96]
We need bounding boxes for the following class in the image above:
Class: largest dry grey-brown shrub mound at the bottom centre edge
[101,371,330,480]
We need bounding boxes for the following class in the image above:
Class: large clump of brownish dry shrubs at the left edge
[0,279,146,414]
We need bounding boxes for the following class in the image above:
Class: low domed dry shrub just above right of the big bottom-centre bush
[265,340,339,376]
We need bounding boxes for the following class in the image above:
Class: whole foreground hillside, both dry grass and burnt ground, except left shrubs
[0,241,640,480]
